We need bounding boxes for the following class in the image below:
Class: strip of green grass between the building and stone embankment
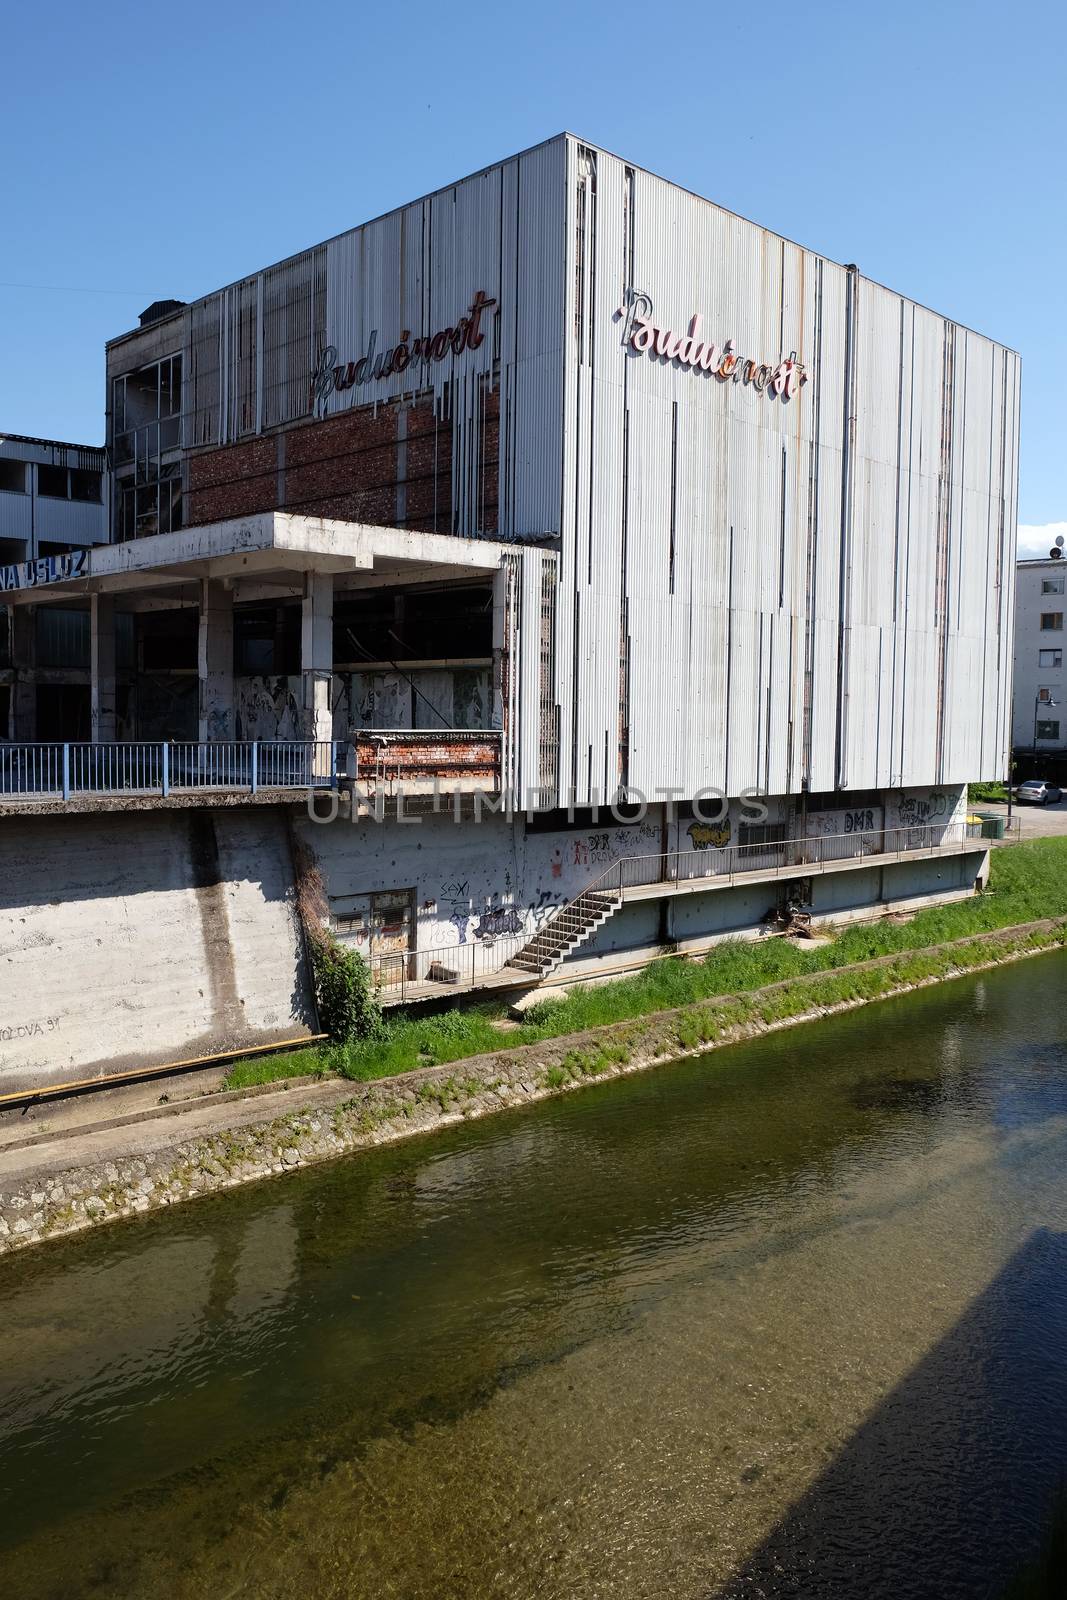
[226,838,1067,1088]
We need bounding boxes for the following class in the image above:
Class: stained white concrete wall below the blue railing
[0,808,314,1093]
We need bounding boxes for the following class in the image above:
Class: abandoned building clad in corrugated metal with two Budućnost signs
[0,134,1019,1083]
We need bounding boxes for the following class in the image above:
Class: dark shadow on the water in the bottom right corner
[713,1229,1067,1600]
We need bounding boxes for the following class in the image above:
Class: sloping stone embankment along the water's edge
[0,918,1067,1254]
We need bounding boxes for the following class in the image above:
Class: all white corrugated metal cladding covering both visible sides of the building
[164,136,1019,803]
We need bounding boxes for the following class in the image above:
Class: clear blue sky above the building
[0,0,1067,550]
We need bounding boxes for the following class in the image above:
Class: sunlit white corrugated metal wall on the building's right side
[557,139,1019,795]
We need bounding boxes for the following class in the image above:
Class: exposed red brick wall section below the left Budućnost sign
[186,387,499,533]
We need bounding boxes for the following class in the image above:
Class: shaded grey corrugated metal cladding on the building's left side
[170,138,566,538]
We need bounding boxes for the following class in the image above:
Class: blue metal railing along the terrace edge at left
[0,739,337,800]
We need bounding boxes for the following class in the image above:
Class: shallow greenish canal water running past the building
[0,954,1067,1600]
